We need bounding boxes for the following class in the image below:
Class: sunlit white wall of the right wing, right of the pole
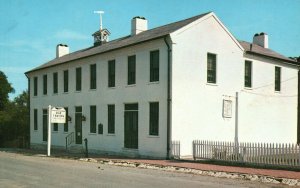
[239,55,298,143]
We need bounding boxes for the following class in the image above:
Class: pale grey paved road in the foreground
[0,152,285,188]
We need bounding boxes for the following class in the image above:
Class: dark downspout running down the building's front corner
[164,36,171,159]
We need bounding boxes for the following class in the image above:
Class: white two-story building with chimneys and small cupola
[26,12,299,158]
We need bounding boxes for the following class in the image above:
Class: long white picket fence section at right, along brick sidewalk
[193,140,300,167]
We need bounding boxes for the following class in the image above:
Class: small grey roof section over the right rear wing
[239,41,299,65]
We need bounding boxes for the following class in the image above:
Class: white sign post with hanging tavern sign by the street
[47,105,66,157]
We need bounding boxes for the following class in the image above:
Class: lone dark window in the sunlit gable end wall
[207,53,217,84]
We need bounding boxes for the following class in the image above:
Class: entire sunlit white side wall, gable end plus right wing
[171,16,297,156]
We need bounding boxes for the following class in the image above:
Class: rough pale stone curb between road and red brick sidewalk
[79,158,300,186]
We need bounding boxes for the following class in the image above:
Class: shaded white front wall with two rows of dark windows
[30,39,167,157]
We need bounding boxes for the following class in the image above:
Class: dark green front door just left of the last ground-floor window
[124,104,138,149]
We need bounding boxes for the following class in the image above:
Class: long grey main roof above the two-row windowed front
[25,12,210,74]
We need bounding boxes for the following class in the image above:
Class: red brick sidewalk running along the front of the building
[0,148,300,180]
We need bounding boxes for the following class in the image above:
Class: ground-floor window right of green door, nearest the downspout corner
[149,102,159,136]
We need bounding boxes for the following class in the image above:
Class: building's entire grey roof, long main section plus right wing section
[25,12,299,74]
